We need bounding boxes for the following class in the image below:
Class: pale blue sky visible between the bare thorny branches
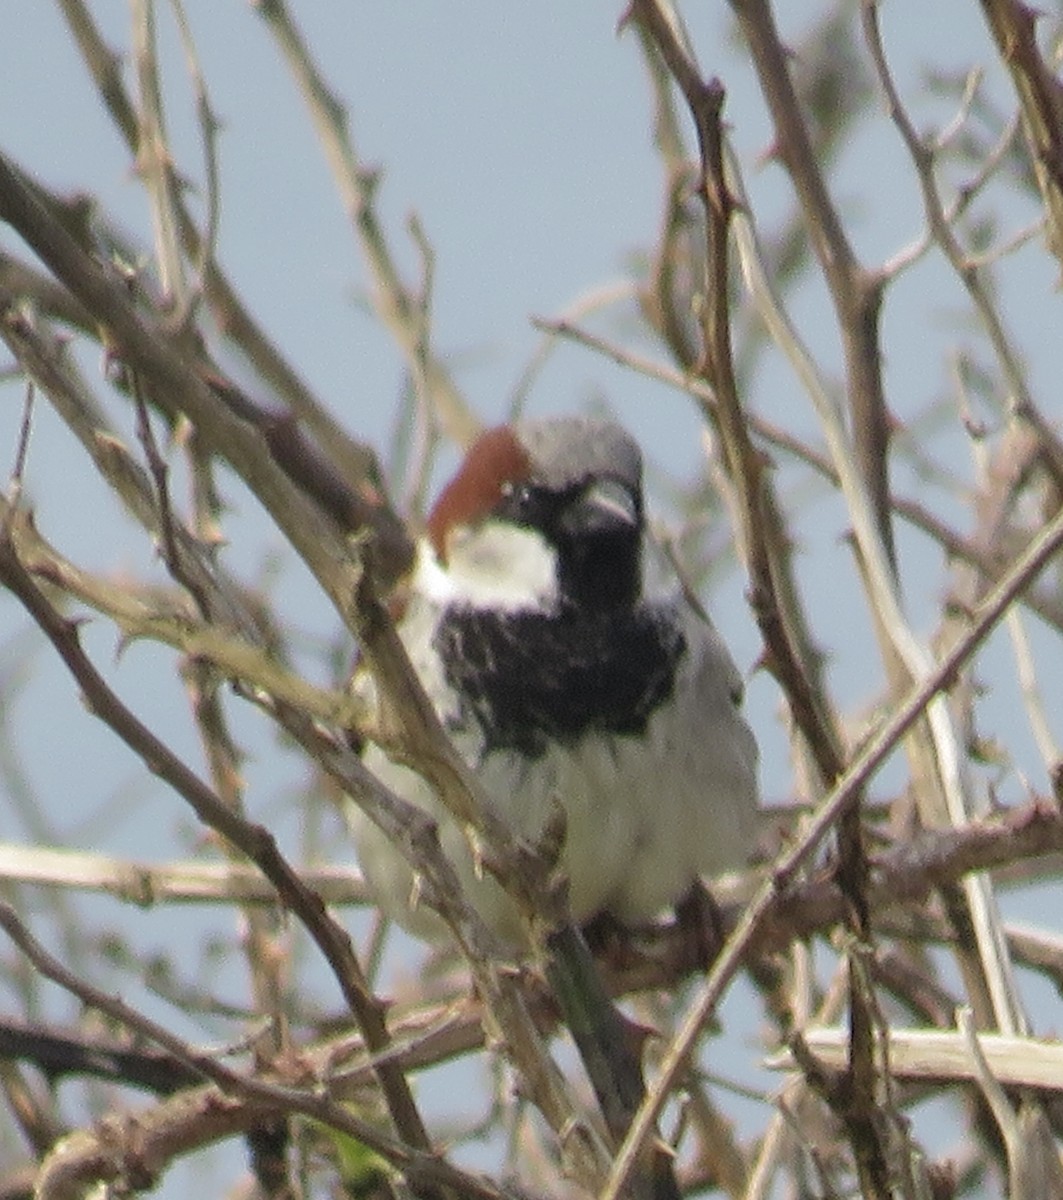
[0,0,1059,1190]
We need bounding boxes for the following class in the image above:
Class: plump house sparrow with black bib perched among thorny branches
[349,418,757,943]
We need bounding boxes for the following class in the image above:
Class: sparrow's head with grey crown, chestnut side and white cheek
[422,418,643,611]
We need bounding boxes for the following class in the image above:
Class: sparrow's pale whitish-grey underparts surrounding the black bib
[350,601,757,942]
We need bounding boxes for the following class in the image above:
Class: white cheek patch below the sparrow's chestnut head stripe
[419,521,558,612]
